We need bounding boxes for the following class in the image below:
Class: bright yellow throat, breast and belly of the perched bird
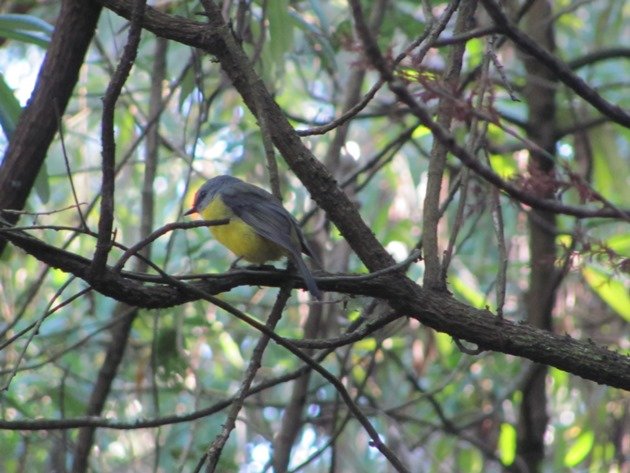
[200,197,286,264]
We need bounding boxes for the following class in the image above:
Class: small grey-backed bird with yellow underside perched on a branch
[184,175,322,300]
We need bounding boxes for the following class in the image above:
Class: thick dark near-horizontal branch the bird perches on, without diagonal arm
[2,230,630,390]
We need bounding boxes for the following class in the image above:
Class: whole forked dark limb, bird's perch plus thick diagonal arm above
[4,0,630,390]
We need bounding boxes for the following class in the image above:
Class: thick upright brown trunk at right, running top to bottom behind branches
[516,0,557,471]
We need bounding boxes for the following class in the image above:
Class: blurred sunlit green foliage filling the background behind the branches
[0,0,630,472]
